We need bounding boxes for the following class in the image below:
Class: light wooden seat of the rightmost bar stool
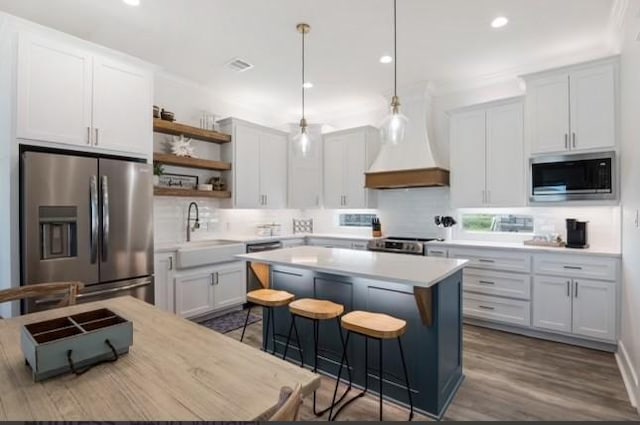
[342,311,407,339]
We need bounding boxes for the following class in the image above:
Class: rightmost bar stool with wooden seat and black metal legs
[329,311,413,421]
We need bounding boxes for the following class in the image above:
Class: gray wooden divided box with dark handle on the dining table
[20,308,133,381]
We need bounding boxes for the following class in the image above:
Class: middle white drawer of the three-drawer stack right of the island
[463,268,531,300]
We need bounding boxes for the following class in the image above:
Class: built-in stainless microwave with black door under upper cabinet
[529,152,618,202]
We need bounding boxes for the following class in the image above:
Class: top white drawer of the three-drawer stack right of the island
[449,249,531,273]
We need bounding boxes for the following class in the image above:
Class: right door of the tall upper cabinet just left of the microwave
[486,103,525,207]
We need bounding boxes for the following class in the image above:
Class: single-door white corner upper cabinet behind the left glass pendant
[289,129,322,209]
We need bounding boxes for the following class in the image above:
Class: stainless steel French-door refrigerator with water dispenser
[20,151,153,313]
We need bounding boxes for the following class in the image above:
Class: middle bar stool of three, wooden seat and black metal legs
[282,298,351,416]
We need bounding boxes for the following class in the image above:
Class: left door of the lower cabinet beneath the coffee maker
[533,276,572,332]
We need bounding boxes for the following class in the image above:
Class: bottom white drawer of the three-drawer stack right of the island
[463,293,531,326]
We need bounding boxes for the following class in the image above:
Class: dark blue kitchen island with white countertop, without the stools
[238,246,467,418]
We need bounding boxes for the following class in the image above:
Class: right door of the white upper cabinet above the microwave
[570,65,616,150]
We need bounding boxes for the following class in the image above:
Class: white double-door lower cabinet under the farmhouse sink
[175,262,246,318]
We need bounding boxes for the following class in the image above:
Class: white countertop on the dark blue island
[236,246,468,288]
